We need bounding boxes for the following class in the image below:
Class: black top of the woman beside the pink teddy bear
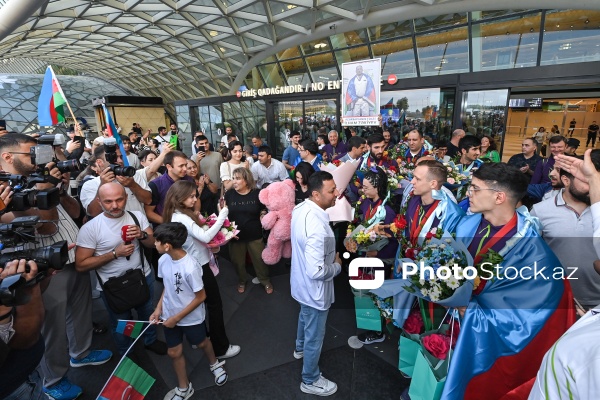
[225,189,266,241]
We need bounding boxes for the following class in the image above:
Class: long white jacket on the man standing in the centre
[290,199,342,310]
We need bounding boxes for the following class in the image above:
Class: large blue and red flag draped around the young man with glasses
[442,213,575,400]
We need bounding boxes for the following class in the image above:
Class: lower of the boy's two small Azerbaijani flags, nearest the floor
[98,357,156,400]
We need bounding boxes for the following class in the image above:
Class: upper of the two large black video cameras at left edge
[0,172,60,211]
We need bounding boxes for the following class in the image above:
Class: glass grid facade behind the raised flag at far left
[0,74,139,133]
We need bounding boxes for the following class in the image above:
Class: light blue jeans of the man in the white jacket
[296,304,329,385]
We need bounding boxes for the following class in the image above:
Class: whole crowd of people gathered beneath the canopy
[0,124,600,400]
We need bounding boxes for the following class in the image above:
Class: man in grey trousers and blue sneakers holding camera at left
[0,133,112,399]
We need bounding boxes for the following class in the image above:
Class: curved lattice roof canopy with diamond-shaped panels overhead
[0,0,600,101]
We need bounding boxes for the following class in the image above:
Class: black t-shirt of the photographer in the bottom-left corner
[0,335,46,399]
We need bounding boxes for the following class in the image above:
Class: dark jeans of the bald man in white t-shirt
[100,272,156,355]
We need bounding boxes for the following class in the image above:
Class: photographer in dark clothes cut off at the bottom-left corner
[0,260,47,400]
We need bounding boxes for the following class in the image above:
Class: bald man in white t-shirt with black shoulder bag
[75,182,167,355]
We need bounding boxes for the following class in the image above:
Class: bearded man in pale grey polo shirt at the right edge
[531,150,600,310]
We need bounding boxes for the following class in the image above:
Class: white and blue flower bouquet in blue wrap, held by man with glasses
[395,233,475,307]
